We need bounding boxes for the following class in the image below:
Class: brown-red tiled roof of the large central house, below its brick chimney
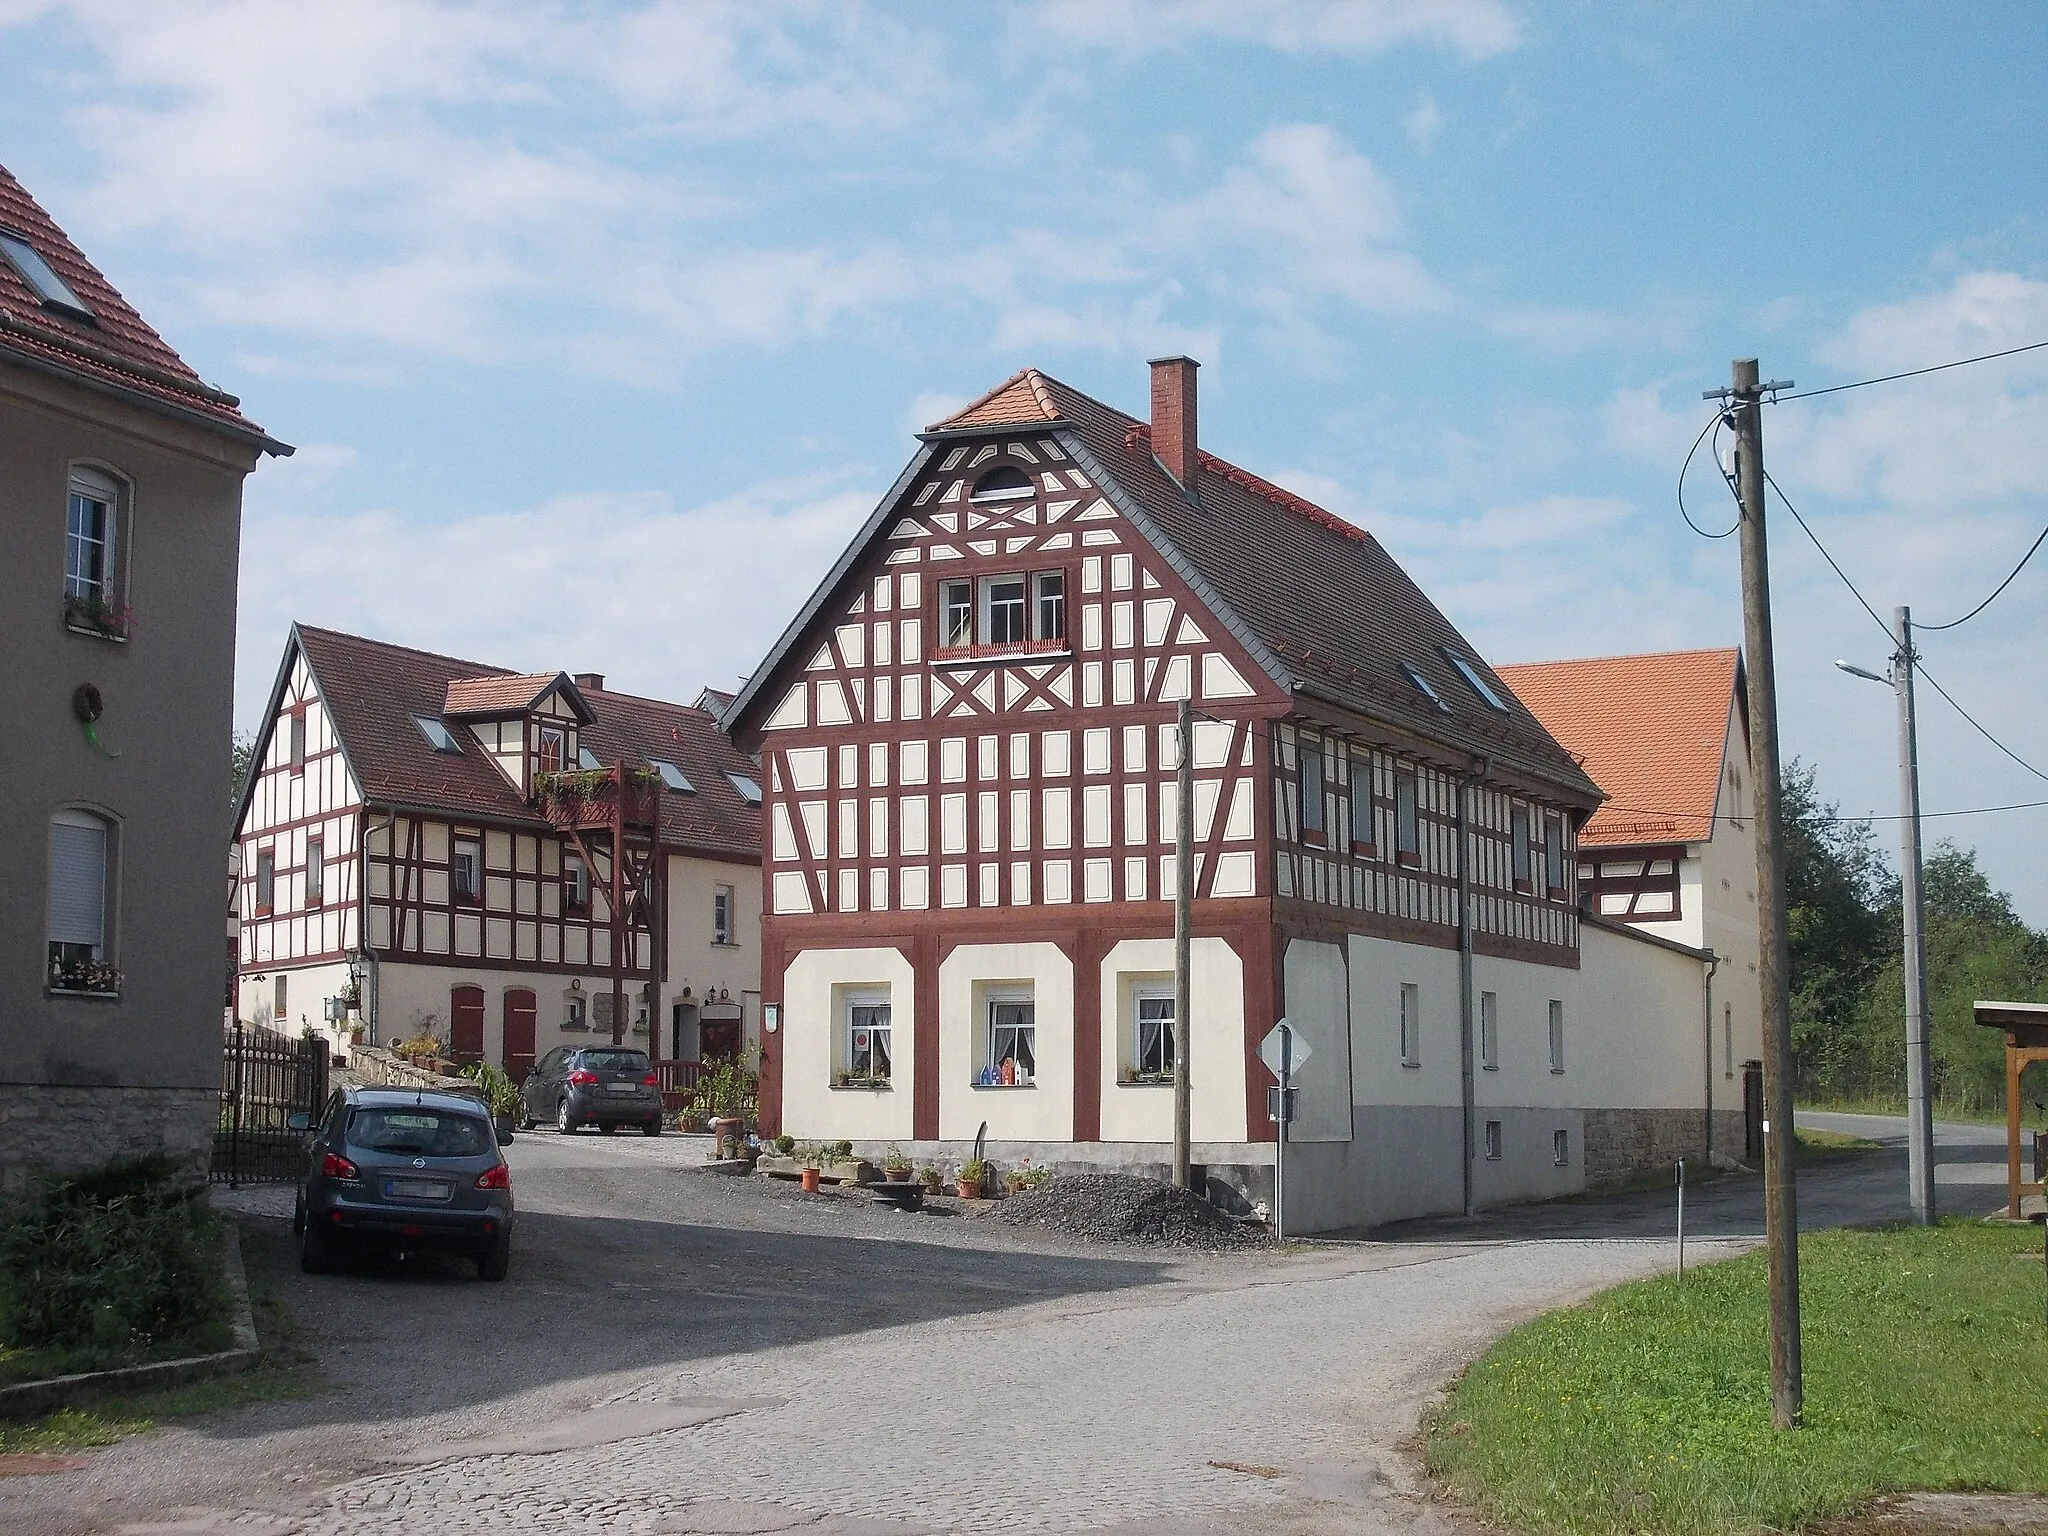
[932,369,1597,803]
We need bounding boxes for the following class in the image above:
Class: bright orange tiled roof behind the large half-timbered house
[1499,649,1743,848]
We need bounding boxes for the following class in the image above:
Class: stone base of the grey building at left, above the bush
[0,1083,221,1204]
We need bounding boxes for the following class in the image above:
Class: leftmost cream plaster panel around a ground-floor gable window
[782,948,917,1143]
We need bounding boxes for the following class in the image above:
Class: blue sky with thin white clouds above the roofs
[0,0,2048,924]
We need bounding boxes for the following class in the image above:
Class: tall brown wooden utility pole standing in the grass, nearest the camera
[1706,358,1806,1430]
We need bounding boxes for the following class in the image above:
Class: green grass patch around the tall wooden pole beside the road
[1425,1223,2048,1536]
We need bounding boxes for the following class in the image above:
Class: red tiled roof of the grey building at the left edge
[0,166,278,453]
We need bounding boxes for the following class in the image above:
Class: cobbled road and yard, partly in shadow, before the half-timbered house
[0,1135,1761,1536]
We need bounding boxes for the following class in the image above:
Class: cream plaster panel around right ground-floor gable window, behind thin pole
[1100,938,1247,1143]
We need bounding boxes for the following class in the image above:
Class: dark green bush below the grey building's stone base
[0,1155,229,1362]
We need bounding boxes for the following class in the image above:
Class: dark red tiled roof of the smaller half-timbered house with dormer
[293,625,762,858]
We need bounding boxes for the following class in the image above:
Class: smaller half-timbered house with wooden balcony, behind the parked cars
[236,625,762,1081]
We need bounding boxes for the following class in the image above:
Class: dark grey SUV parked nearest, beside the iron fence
[291,1087,512,1280]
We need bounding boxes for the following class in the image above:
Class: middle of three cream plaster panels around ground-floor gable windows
[938,944,1073,1141]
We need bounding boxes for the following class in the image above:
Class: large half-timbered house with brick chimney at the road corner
[725,358,1736,1229]
